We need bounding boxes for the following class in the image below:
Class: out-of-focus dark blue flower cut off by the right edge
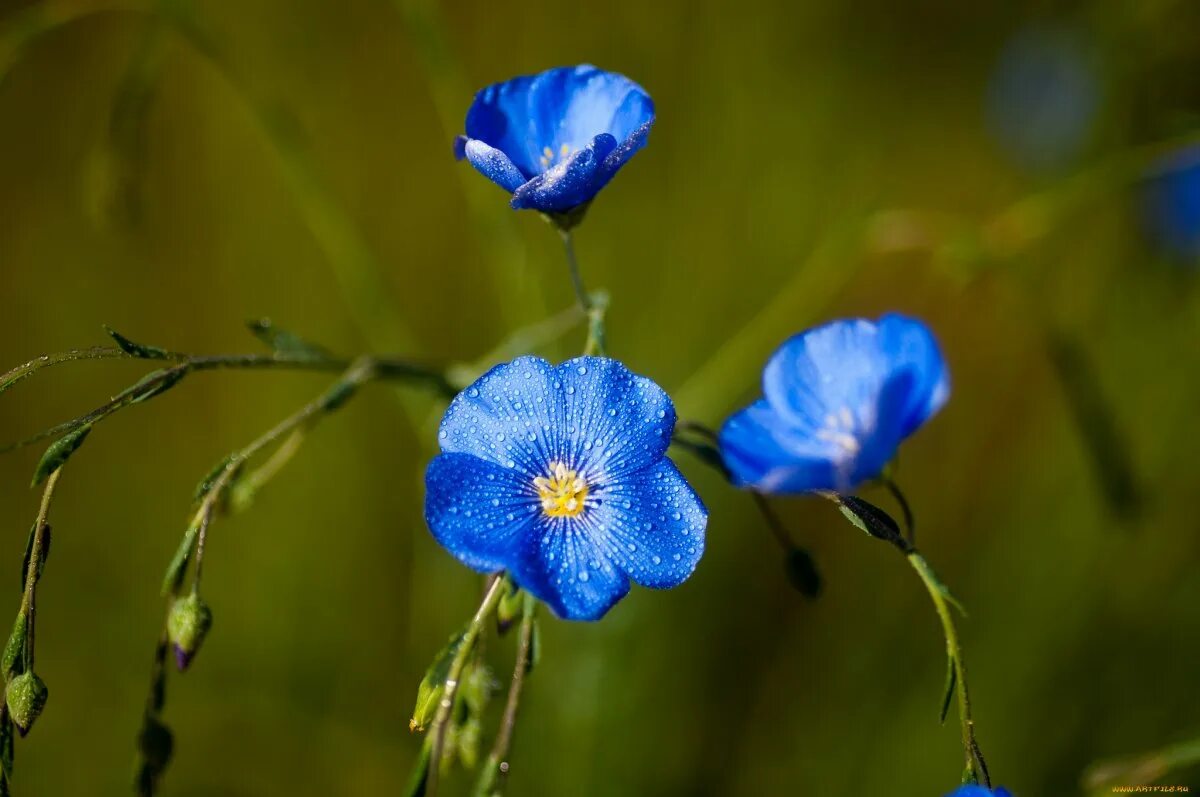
[1142,145,1200,264]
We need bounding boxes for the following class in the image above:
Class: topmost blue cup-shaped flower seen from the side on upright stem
[455,64,654,215]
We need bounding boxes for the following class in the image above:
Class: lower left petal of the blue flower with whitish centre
[719,399,842,495]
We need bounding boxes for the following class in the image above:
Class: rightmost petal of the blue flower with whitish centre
[878,313,950,438]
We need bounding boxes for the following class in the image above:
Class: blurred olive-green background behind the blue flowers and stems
[0,0,1200,797]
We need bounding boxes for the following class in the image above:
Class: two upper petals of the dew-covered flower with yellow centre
[438,356,676,485]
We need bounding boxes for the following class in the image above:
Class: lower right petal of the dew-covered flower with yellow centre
[578,459,708,589]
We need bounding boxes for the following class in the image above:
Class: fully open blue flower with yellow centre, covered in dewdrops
[425,356,708,619]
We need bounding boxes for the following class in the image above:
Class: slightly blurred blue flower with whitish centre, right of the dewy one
[719,314,950,493]
